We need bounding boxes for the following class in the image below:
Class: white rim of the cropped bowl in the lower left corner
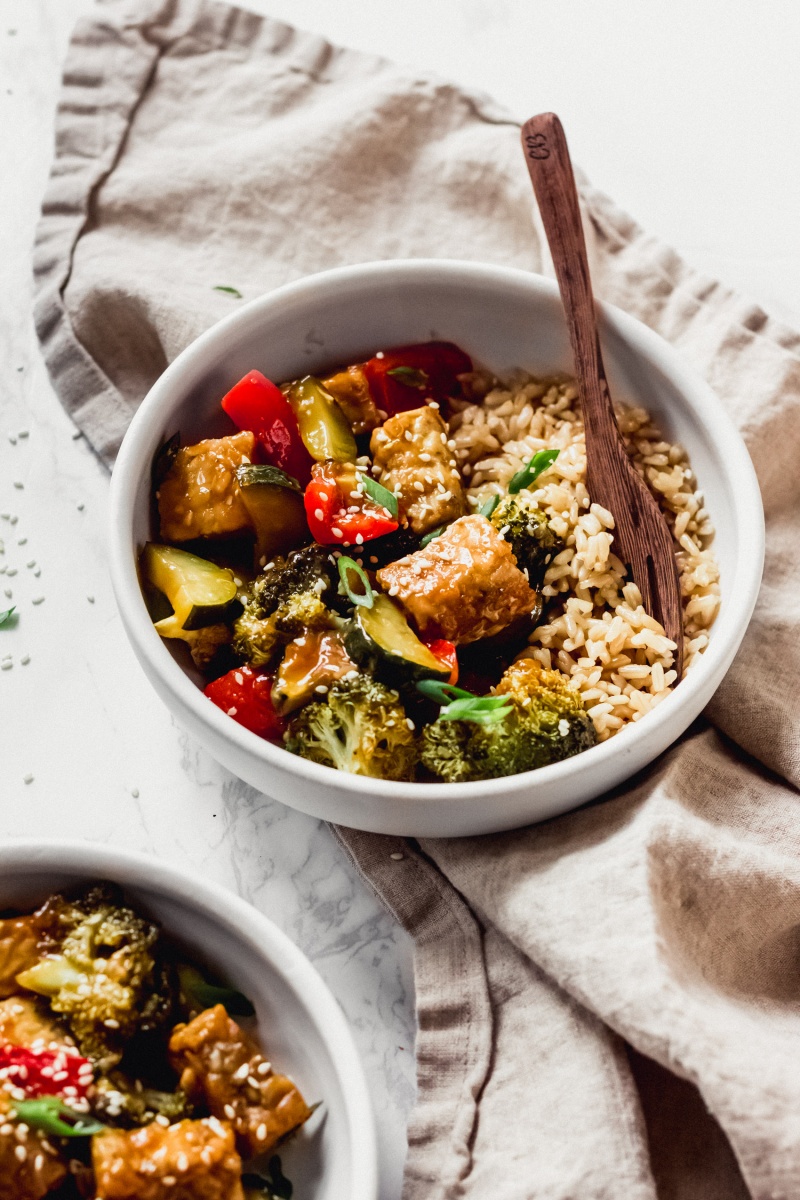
[0,838,378,1200]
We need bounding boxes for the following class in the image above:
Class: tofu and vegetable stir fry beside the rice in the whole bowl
[142,341,591,781]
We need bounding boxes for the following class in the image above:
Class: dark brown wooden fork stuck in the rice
[522,113,684,679]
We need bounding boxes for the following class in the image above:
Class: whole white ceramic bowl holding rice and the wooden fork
[109,260,764,836]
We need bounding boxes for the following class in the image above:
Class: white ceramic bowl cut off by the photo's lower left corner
[0,841,378,1200]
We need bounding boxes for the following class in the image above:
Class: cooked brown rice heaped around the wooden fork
[450,372,720,742]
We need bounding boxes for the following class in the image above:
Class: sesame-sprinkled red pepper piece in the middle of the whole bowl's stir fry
[305,462,398,546]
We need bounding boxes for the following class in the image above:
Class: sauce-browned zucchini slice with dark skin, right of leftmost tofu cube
[236,463,311,569]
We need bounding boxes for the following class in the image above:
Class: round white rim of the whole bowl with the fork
[109,258,764,808]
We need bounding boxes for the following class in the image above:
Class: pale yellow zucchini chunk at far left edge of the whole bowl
[142,541,241,637]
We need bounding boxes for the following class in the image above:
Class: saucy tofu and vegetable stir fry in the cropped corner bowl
[0,883,318,1200]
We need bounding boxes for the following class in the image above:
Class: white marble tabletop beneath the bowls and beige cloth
[0,0,800,1200]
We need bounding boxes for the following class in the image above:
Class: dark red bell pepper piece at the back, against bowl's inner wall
[362,342,473,416]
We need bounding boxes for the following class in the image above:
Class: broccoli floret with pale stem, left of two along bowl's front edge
[287,676,419,779]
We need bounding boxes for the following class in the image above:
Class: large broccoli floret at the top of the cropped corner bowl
[17,884,175,1072]
